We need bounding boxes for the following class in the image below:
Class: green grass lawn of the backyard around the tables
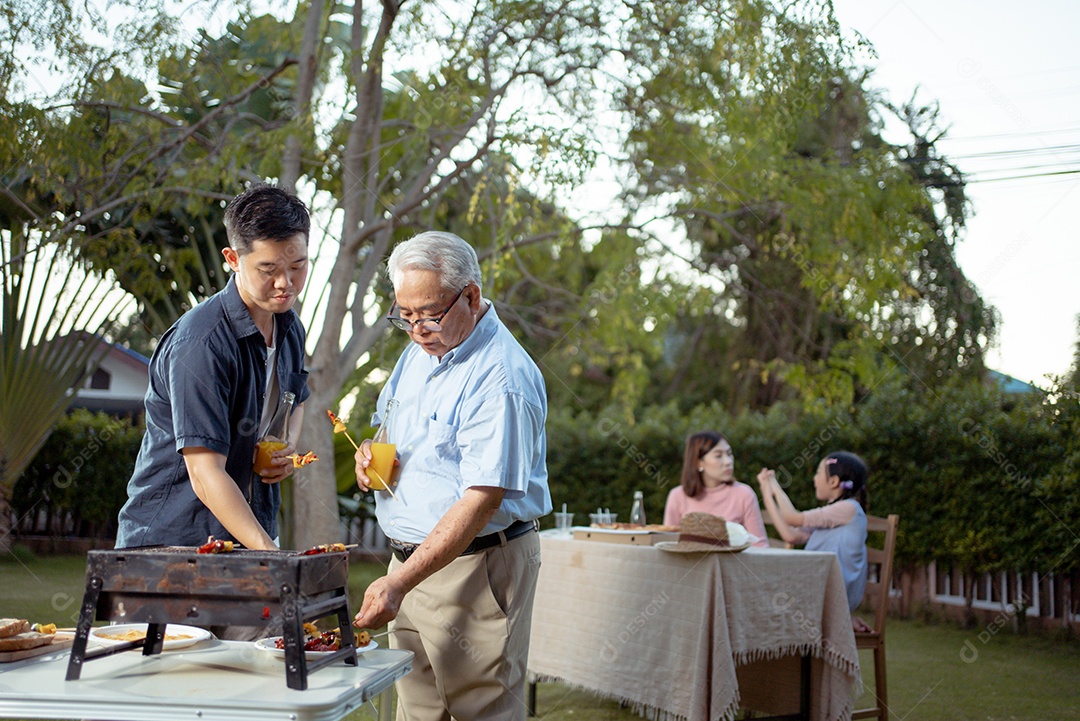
[0,556,1080,721]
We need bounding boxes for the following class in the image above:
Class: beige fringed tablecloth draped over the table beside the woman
[529,533,860,721]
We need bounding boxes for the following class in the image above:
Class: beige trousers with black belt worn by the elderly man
[390,533,540,721]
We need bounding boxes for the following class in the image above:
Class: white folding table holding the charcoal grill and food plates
[0,639,413,721]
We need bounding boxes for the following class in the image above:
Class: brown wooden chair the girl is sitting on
[851,514,900,721]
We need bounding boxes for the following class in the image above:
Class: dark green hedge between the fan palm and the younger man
[12,409,143,539]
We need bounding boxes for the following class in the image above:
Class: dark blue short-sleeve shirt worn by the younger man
[117,278,309,548]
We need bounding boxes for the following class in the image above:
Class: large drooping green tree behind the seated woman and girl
[624,1,993,409]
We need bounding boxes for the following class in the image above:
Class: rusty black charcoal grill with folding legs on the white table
[67,546,356,691]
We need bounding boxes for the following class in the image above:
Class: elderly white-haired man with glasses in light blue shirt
[355,232,552,721]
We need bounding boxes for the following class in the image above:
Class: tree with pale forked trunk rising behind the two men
[2,0,617,545]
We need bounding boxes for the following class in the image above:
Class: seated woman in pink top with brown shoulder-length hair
[664,431,769,548]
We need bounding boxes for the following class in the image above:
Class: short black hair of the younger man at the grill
[225,182,311,255]
